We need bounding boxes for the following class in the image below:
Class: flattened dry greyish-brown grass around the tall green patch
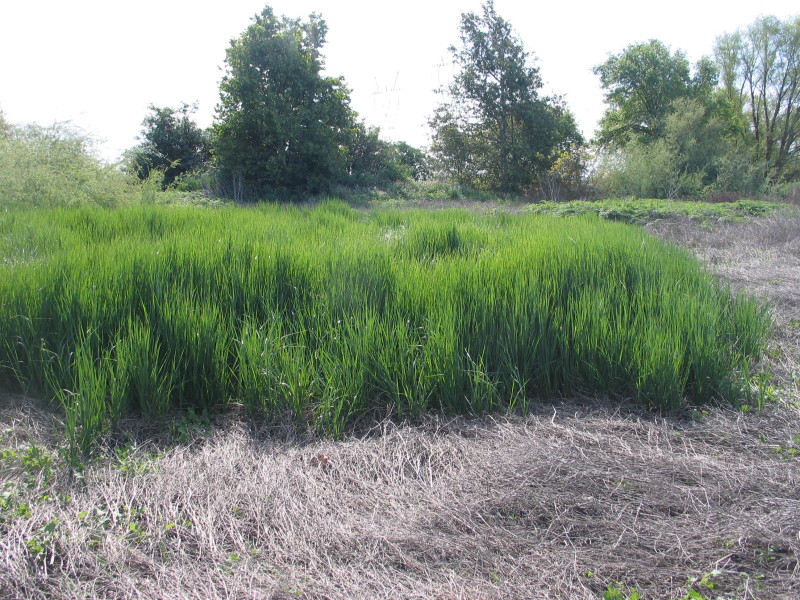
[0,209,800,600]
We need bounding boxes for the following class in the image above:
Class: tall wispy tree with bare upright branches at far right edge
[715,16,800,181]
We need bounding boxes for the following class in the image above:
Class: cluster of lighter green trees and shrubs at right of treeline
[595,17,800,198]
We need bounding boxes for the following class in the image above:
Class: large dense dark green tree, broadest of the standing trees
[213,6,355,196]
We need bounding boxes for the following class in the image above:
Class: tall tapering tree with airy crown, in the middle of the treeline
[430,0,582,192]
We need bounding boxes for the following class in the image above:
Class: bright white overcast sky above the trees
[0,0,800,160]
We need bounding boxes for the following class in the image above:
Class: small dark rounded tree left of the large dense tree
[130,103,211,188]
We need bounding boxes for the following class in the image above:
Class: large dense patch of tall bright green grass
[0,201,768,450]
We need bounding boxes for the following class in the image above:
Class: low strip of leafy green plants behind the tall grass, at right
[525,198,786,225]
